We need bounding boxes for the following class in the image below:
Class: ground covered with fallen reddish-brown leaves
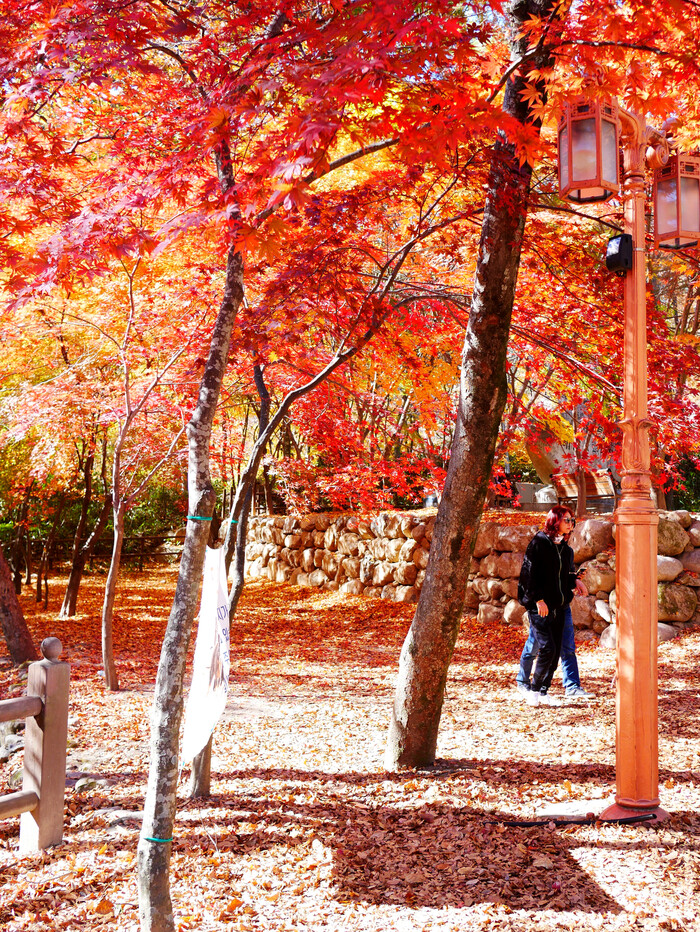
[0,569,700,932]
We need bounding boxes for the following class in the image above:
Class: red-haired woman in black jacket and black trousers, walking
[518,505,587,705]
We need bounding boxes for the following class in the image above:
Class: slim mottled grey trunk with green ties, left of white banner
[138,247,243,932]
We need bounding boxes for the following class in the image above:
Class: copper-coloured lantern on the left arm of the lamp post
[559,98,620,204]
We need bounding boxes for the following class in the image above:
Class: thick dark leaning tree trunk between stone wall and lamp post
[385,0,553,769]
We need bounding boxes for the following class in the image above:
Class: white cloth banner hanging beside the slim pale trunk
[181,547,231,764]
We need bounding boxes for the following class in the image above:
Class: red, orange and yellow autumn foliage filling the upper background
[0,3,700,572]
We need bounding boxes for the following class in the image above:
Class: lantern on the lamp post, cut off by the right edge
[654,153,700,249]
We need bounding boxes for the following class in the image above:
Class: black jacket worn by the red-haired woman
[518,531,576,612]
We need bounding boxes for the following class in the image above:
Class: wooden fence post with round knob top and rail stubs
[0,638,70,854]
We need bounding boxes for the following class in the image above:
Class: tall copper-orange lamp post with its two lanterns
[559,99,700,819]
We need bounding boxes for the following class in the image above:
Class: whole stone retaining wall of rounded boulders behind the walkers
[246,511,700,643]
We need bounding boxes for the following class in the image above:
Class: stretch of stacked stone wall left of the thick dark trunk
[246,512,435,602]
